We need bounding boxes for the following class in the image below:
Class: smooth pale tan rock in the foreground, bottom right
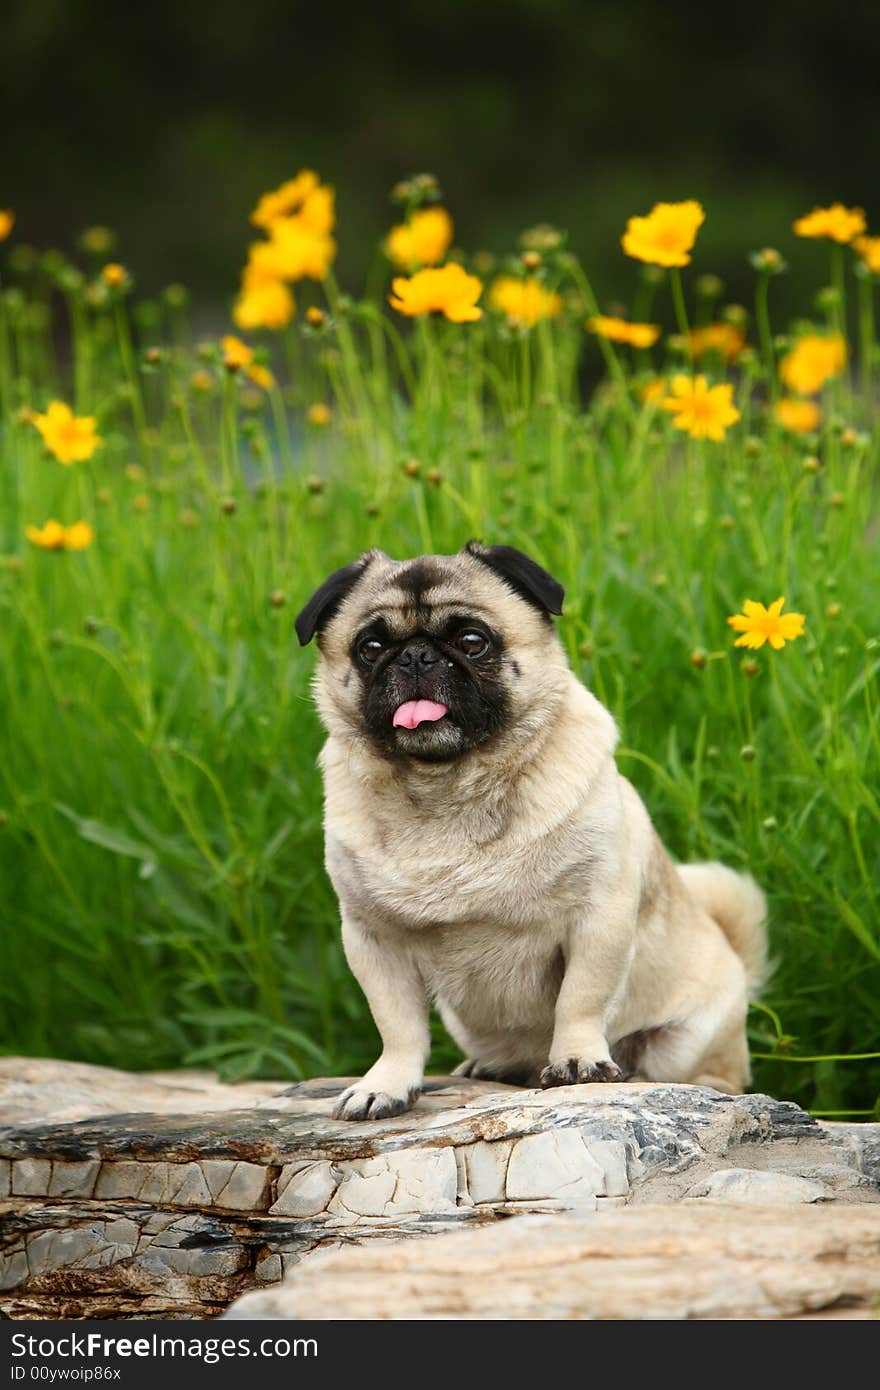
[227,1202,880,1319]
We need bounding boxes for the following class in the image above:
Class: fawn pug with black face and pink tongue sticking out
[296,541,766,1120]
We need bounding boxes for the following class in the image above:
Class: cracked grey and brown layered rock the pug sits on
[0,1059,880,1318]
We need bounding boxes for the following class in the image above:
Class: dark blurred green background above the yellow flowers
[6,0,880,317]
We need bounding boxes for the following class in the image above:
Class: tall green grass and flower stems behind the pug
[0,214,880,1113]
